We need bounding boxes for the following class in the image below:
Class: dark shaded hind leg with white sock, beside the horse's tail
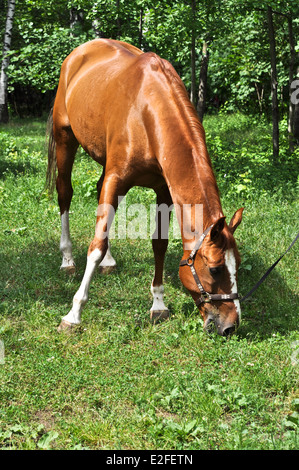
[55,127,78,274]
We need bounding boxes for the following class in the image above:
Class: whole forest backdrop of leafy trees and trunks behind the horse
[0,0,299,159]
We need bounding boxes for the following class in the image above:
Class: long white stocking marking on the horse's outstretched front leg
[63,248,102,325]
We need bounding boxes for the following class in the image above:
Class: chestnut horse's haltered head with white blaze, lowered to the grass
[180,209,243,336]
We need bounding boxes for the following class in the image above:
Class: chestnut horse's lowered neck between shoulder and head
[152,89,223,246]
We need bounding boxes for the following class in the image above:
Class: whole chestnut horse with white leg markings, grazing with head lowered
[47,39,243,336]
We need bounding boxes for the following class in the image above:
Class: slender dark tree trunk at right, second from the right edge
[267,7,279,161]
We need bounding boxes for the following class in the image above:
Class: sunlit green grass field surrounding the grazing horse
[0,115,299,450]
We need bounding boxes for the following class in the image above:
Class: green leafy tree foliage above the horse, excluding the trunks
[0,0,299,118]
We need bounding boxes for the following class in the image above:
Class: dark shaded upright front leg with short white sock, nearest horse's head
[150,187,172,322]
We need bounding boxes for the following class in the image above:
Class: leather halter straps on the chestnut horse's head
[180,224,239,306]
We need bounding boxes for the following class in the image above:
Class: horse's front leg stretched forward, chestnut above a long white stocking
[58,175,126,331]
